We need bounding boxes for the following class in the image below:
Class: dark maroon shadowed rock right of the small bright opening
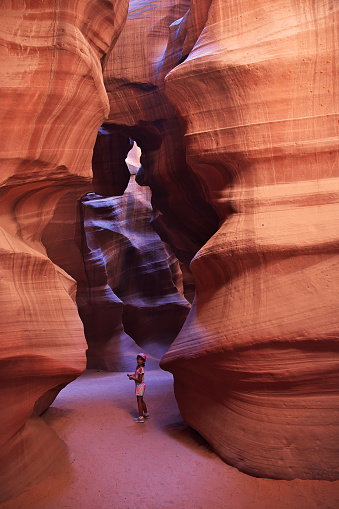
[99,121,219,265]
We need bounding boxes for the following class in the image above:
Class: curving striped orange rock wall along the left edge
[0,0,128,500]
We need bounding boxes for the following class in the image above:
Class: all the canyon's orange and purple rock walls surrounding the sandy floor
[0,0,339,509]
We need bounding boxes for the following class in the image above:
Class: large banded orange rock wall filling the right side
[162,0,339,480]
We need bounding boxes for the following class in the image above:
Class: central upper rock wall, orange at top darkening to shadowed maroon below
[104,0,218,264]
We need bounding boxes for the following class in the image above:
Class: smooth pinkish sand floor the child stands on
[1,365,339,509]
